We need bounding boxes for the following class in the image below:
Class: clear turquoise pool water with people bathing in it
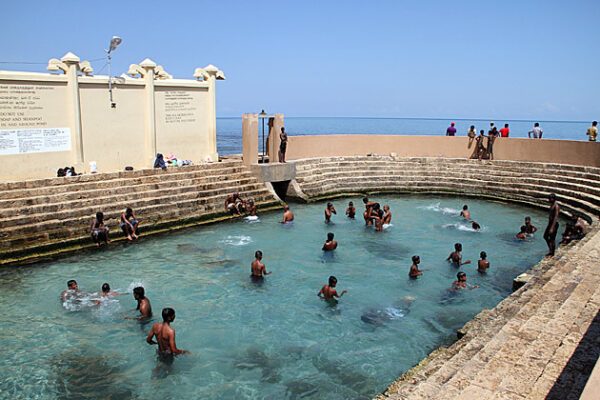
[0,196,552,399]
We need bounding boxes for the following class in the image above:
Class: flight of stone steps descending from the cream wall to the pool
[0,160,279,265]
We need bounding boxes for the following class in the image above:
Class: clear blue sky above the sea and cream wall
[0,0,600,121]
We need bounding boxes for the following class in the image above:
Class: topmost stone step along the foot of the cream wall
[0,162,249,199]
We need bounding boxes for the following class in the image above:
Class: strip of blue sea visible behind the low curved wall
[217,116,591,155]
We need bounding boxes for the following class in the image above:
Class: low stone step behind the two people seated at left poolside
[0,190,278,257]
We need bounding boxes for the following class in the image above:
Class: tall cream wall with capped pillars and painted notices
[0,53,224,181]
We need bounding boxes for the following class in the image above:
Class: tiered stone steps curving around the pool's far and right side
[288,157,600,400]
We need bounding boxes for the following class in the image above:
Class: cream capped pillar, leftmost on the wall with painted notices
[60,53,86,167]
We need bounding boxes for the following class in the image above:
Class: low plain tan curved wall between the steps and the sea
[287,135,600,167]
